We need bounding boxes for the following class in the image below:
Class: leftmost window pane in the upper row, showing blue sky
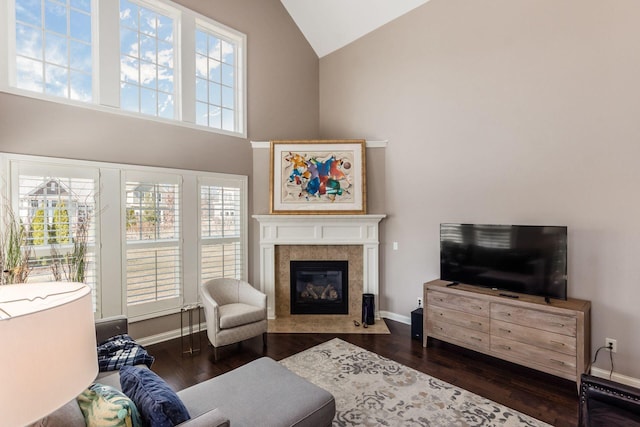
[15,0,92,102]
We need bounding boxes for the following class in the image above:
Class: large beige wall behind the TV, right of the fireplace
[320,0,640,378]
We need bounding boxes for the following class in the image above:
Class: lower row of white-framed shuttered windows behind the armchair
[0,153,248,321]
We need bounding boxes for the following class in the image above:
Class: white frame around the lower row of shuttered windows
[0,153,248,321]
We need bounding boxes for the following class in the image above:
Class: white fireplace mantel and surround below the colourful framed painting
[253,214,386,319]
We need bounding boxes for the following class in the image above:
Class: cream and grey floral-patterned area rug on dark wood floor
[280,338,548,427]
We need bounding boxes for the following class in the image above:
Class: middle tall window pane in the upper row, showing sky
[120,0,176,119]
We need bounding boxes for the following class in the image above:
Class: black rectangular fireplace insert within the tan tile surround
[289,261,349,314]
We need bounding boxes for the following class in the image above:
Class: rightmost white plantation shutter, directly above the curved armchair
[200,178,247,282]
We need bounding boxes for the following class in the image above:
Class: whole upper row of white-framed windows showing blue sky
[0,0,247,137]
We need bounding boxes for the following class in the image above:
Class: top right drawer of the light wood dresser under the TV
[491,303,576,337]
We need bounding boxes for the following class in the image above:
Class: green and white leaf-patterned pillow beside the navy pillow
[77,383,142,427]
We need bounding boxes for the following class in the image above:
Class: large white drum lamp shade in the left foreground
[0,282,98,426]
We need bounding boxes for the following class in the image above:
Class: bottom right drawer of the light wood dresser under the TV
[491,336,576,375]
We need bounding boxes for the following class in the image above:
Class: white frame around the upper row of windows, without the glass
[0,0,247,138]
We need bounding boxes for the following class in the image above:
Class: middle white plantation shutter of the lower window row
[124,173,182,316]
